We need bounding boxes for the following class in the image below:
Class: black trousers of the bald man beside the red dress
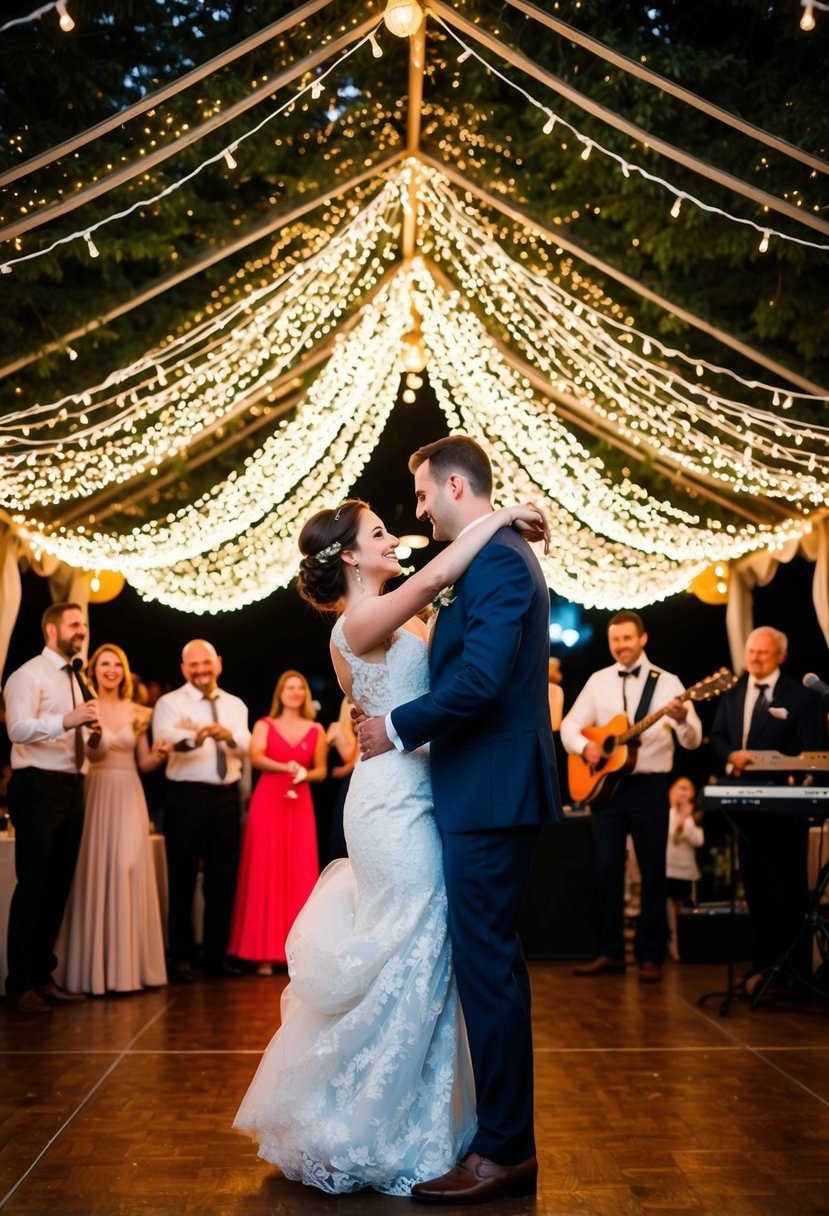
[164,781,241,967]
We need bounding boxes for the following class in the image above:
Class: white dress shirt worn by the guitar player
[560,651,703,773]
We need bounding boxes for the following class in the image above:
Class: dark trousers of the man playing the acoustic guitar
[583,772,669,963]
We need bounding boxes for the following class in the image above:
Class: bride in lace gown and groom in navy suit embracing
[235,437,562,1204]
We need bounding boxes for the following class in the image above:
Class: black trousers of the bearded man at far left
[6,769,84,992]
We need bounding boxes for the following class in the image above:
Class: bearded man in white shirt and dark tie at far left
[5,603,97,1013]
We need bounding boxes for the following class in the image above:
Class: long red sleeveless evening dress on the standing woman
[227,719,320,963]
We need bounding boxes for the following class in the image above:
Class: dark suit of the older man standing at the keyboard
[710,674,827,974]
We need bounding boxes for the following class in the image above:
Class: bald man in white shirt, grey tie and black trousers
[152,638,250,984]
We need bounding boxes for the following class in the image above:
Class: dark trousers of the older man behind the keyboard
[733,811,812,978]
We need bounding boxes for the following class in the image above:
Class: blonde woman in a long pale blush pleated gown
[66,642,170,996]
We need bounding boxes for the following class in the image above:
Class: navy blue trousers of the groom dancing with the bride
[442,827,540,1165]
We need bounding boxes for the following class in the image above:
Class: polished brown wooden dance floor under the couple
[0,962,829,1216]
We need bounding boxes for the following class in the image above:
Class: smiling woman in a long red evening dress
[230,671,327,975]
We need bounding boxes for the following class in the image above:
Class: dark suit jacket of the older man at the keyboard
[710,672,827,769]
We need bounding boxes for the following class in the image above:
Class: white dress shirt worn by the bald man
[152,683,250,786]
